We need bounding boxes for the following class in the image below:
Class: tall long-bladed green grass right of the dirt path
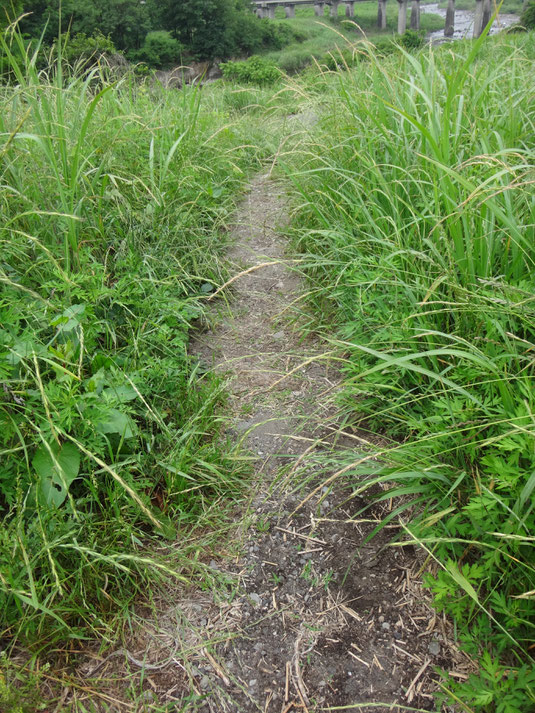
[288,30,535,713]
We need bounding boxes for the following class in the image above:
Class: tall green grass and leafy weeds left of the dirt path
[0,28,276,643]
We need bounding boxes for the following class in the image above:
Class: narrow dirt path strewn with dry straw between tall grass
[76,157,464,713]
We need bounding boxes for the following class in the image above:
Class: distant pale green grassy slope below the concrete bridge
[265,2,444,72]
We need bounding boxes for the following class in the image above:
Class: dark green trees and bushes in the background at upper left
[0,0,302,68]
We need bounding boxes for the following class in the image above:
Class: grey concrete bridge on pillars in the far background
[252,0,492,37]
